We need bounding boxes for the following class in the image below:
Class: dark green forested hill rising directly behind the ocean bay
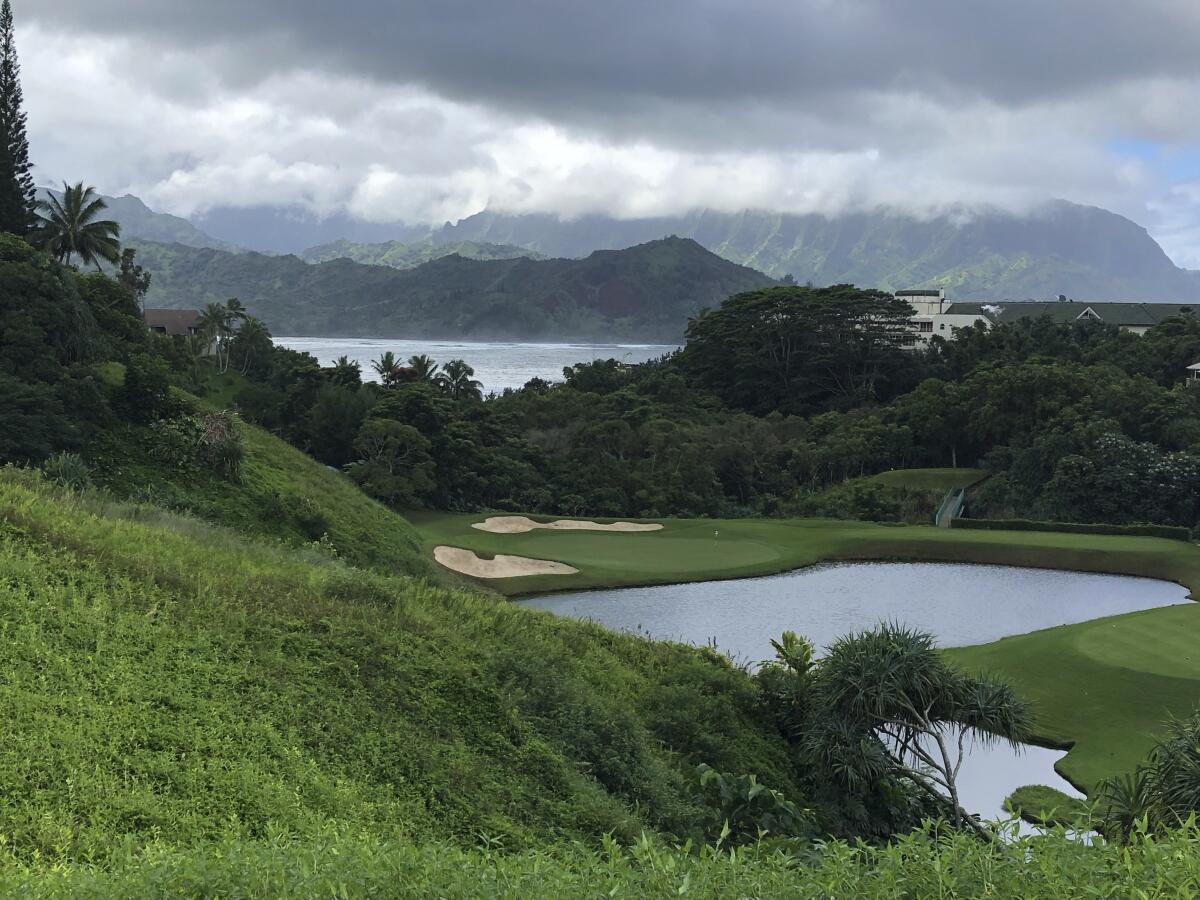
[134,238,773,342]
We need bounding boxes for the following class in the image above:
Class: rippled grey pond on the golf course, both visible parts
[522,563,1190,818]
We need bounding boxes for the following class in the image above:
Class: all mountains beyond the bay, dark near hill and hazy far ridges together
[54,187,1200,340]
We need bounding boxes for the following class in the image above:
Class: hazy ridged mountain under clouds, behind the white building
[436,200,1200,302]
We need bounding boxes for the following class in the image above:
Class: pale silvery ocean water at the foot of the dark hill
[275,337,678,394]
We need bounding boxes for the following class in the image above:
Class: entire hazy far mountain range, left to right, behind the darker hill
[88,188,1200,302]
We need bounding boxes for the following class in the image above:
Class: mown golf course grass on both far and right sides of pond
[412,514,1200,791]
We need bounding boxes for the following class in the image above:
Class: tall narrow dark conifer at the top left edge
[0,0,36,235]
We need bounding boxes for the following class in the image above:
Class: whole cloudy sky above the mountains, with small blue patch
[13,0,1200,268]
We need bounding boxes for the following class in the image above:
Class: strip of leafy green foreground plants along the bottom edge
[0,829,1200,900]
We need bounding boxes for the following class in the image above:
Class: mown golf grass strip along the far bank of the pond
[408,512,1200,596]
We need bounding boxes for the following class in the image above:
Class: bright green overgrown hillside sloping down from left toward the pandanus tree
[0,469,794,862]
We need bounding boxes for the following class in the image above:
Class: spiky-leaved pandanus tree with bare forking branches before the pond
[804,624,1031,839]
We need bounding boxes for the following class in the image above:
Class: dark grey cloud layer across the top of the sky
[25,0,1200,128]
